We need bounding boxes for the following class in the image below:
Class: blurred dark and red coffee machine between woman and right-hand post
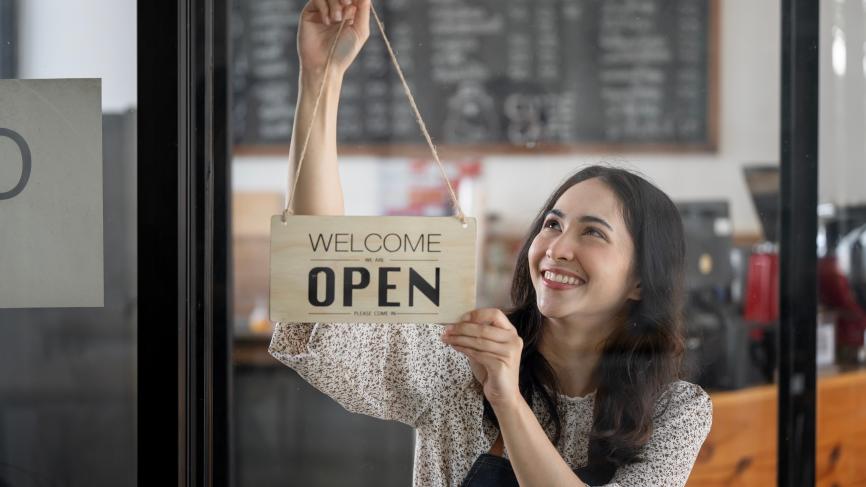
[677,165,779,390]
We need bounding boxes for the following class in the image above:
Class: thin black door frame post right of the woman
[777,0,820,487]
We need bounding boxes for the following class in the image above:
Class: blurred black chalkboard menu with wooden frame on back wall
[232,0,717,151]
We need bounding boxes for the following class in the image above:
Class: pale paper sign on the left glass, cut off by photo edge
[0,79,104,308]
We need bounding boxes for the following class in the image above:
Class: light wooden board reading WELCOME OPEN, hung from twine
[270,215,476,323]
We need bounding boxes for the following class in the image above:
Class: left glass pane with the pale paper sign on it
[0,0,138,487]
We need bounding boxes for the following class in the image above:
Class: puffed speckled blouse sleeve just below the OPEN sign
[269,323,466,427]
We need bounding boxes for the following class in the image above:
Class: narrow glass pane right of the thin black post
[816,0,866,485]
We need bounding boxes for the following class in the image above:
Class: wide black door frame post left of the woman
[137,0,232,487]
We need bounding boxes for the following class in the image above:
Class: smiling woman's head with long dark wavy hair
[509,166,710,476]
